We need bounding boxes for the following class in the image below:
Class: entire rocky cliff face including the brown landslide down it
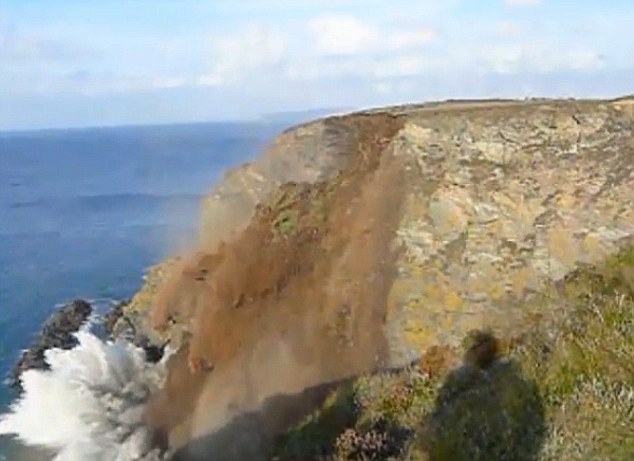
[115,98,634,459]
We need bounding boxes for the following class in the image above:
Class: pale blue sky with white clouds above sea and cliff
[0,0,634,130]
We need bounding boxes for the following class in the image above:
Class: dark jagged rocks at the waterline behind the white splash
[8,299,92,389]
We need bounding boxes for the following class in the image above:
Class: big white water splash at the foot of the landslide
[0,330,169,461]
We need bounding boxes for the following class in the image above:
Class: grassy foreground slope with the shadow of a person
[275,246,634,461]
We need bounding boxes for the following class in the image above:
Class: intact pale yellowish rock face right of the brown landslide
[390,103,634,362]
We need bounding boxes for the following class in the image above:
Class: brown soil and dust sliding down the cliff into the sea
[147,115,405,447]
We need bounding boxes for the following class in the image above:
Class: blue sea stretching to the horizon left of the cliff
[0,121,290,460]
